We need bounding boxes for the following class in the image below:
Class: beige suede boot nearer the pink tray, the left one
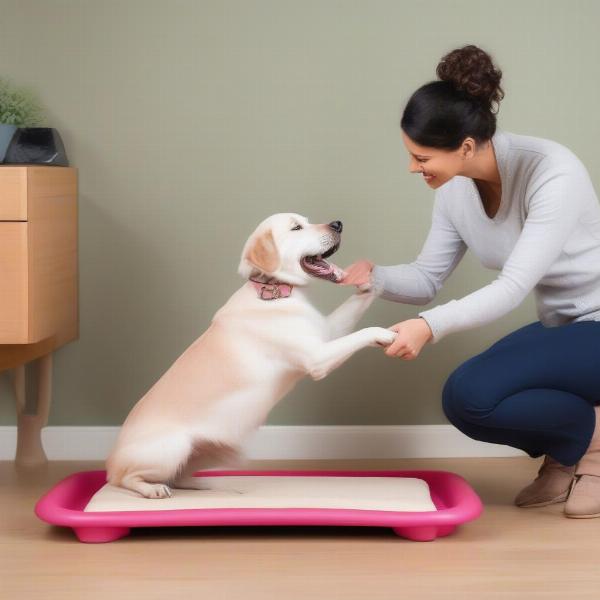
[515,456,576,508]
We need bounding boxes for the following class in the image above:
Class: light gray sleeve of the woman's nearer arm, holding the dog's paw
[419,170,580,343]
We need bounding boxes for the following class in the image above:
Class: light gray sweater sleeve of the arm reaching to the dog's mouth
[371,190,467,305]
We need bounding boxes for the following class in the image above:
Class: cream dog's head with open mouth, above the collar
[238,213,342,285]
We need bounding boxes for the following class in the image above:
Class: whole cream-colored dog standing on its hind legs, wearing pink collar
[106,213,396,498]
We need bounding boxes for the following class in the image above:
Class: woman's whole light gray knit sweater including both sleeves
[371,130,600,343]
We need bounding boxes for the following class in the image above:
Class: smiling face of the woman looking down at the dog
[402,131,474,188]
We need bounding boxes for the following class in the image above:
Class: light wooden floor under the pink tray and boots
[0,457,600,600]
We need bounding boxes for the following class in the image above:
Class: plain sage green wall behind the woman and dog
[0,0,600,425]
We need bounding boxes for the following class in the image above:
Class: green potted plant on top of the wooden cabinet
[0,77,43,162]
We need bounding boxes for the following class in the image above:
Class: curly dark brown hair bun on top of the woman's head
[436,45,504,112]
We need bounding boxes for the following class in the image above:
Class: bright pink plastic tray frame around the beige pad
[35,471,483,543]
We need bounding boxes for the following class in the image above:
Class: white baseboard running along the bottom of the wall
[0,425,527,460]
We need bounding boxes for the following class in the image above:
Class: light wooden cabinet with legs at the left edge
[0,165,79,463]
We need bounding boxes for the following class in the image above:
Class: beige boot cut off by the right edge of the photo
[565,406,600,519]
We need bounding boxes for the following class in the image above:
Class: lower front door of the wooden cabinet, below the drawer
[0,221,29,344]
